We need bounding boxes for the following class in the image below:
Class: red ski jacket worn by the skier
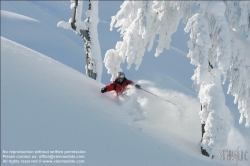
[105,78,134,96]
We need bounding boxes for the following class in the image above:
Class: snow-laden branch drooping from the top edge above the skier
[103,0,191,80]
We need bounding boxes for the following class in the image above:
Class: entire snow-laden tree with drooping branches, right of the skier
[104,0,250,158]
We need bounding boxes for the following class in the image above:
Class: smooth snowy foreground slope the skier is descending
[1,37,248,165]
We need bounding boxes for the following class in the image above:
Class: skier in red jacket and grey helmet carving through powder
[101,72,140,96]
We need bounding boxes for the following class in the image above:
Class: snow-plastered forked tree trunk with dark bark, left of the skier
[57,0,102,82]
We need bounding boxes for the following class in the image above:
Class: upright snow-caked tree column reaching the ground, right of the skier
[185,1,231,154]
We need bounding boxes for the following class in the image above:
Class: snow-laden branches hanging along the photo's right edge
[226,1,250,127]
